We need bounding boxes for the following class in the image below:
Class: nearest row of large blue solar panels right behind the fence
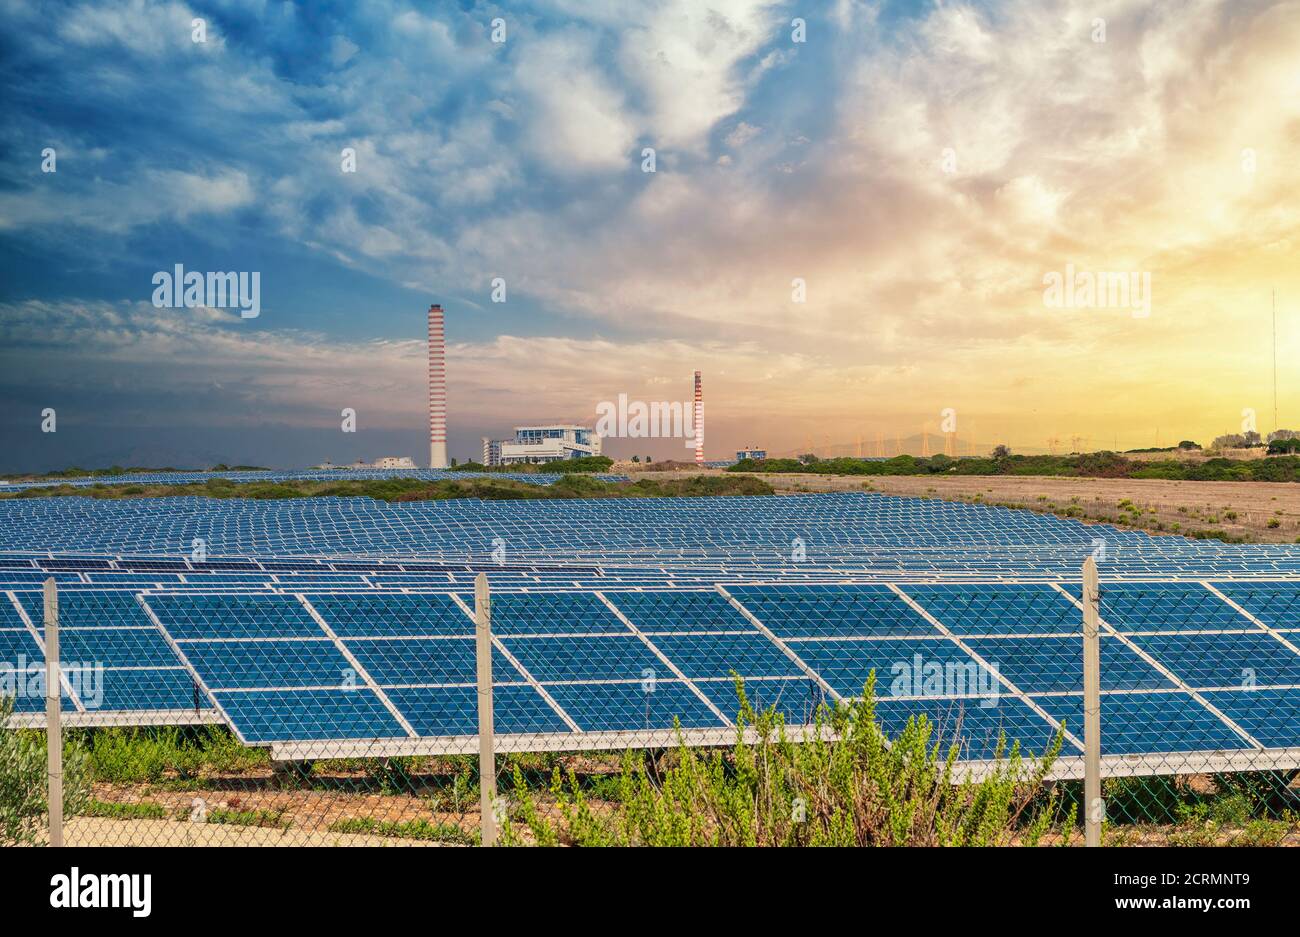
[0,584,1300,756]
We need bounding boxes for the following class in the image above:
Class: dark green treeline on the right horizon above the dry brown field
[727,452,1300,482]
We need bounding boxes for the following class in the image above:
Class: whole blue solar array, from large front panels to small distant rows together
[0,493,1300,774]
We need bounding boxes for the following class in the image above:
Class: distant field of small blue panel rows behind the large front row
[0,493,1300,578]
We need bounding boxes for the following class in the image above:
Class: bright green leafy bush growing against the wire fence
[502,673,1062,846]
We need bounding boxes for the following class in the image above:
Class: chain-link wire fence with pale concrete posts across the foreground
[0,577,1300,846]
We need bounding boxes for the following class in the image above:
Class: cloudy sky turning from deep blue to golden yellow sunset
[0,0,1300,472]
